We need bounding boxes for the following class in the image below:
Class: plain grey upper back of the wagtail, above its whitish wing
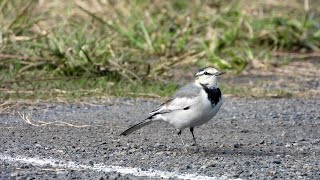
[173,82,201,98]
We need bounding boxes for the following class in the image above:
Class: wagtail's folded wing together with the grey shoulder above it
[150,83,201,115]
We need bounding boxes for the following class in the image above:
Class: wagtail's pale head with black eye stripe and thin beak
[195,67,224,87]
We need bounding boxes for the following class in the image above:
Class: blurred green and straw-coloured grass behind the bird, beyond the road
[0,0,320,100]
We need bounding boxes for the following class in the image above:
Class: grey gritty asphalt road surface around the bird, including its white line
[0,98,320,179]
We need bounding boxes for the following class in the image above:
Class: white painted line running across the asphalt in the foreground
[0,154,238,180]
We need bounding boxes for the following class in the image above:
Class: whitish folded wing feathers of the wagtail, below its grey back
[150,97,195,115]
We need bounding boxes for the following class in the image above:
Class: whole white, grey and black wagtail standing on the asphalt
[120,67,223,144]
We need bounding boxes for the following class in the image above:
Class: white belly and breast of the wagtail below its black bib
[163,91,222,130]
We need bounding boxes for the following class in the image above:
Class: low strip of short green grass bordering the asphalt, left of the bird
[0,71,177,101]
